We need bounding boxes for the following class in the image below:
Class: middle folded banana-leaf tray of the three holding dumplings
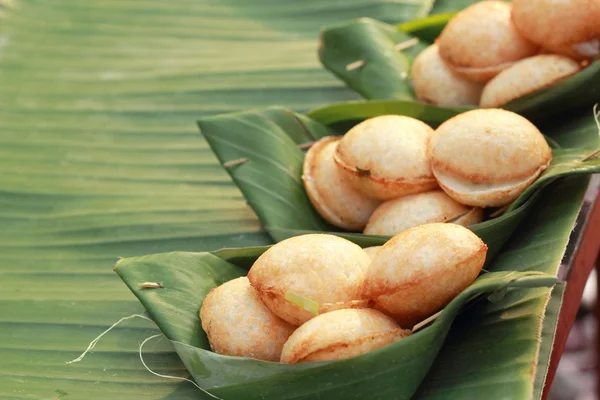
[198,108,600,262]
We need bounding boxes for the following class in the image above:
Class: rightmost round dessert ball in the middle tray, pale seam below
[429,108,552,207]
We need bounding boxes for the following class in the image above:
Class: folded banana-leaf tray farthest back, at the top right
[319,15,600,121]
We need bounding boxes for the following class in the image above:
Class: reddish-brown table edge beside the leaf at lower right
[542,177,600,400]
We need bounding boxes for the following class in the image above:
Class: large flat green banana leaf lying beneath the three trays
[0,0,597,400]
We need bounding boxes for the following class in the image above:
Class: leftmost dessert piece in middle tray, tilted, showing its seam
[302,136,379,231]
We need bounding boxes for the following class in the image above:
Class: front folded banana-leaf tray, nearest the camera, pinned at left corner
[115,248,556,400]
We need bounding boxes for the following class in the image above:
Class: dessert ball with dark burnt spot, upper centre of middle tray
[334,115,437,200]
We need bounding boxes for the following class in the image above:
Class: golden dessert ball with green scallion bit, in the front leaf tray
[248,234,371,325]
